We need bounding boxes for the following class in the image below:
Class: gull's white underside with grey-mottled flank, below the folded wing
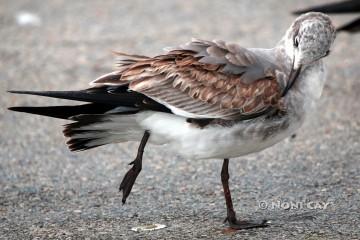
[143,111,301,159]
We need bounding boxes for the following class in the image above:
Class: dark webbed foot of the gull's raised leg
[119,159,142,204]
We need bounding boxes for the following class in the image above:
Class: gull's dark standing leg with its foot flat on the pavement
[221,158,268,230]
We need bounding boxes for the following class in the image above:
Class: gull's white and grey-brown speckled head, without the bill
[285,12,336,69]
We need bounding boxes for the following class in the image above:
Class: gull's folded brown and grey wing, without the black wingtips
[91,40,282,119]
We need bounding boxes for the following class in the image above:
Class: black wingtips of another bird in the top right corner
[293,0,360,33]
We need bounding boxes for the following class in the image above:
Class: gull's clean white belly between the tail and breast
[139,112,301,159]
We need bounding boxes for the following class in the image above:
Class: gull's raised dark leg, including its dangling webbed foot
[119,131,150,204]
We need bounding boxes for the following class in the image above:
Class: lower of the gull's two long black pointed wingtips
[9,103,123,119]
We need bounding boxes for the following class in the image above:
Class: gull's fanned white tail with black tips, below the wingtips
[63,114,144,151]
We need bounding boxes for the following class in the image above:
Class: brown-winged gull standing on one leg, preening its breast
[9,12,336,230]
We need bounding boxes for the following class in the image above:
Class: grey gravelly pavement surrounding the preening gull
[0,0,360,239]
